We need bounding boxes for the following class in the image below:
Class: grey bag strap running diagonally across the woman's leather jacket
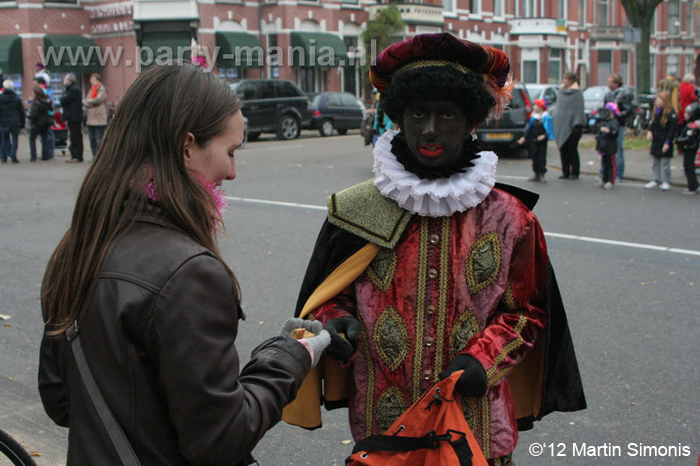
[66,320,141,466]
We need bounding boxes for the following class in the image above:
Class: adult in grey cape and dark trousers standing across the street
[552,71,586,180]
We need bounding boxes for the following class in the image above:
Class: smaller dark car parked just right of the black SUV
[309,92,365,137]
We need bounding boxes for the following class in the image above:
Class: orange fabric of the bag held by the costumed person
[347,371,488,466]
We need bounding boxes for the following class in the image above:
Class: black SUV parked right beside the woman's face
[231,79,311,141]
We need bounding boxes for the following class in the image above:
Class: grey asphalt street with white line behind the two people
[0,132,700,466]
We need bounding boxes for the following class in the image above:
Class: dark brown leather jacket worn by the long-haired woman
[39,212,311,466]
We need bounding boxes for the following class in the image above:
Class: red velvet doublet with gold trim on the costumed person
[313,189,547,458]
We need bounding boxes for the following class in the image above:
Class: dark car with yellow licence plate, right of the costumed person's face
[476,83,532,155]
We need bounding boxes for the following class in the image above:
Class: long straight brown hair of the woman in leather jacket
[42,63,241,335]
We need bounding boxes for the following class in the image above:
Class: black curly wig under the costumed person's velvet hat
[381,66,496,128]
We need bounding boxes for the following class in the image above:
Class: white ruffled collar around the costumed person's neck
[374,130,498,217]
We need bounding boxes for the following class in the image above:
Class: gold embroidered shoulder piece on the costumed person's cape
[328,180,411,249]
